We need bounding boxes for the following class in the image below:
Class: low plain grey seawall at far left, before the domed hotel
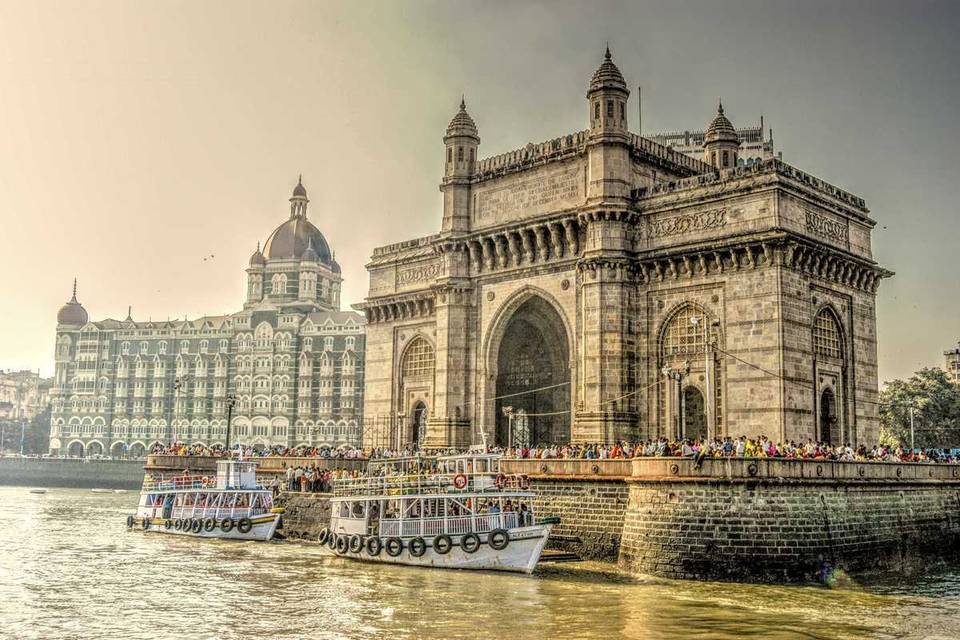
[0,458,143,489]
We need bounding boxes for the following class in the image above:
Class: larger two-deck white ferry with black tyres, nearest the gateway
[318,454,559,573]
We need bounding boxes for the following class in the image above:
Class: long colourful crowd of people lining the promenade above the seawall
[151,436,960,464]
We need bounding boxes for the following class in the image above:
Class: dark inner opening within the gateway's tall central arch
[495,296,570,446]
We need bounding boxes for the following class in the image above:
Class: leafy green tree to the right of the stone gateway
[880,368,960,448]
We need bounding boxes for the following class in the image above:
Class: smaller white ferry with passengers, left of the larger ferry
[127,460,283,540]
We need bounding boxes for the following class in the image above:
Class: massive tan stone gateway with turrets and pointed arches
[356,50,892,448]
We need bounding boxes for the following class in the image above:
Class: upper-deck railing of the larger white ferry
[333,473,528,497]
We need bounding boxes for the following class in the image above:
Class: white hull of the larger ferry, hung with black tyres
[324,524,552,573]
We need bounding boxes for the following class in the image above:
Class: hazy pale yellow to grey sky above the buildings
[0,0,960,379]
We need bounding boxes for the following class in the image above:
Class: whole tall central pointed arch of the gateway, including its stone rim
[478,285,575,445]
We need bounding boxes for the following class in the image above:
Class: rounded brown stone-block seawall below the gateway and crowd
[502,458,960,582]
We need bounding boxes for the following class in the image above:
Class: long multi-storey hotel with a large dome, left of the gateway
[50,183,365,456]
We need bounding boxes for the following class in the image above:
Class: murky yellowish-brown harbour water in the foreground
[0,487,960,640]
